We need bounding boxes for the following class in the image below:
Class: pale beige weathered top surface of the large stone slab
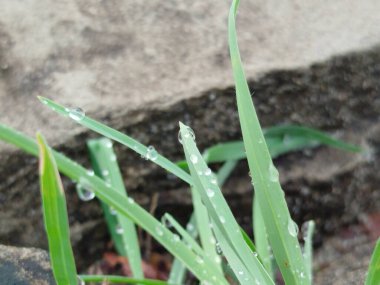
[0,0,380,148]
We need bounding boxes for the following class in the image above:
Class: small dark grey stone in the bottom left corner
[0,245,55,285]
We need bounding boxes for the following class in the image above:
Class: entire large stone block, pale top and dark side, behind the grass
[0,0,380,276]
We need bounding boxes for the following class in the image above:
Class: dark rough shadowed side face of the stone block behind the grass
[0,48,380,278]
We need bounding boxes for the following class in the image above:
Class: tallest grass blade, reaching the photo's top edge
[228,0,310,285]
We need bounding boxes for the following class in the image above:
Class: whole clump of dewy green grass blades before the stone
[0,0,380,285]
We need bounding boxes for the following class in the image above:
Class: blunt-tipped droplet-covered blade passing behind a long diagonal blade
[87,138,144,278]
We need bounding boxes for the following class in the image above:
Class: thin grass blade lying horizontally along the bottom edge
[79,275,171,285]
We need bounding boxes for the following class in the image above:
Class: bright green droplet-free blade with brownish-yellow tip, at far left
[37,134,78,285]
